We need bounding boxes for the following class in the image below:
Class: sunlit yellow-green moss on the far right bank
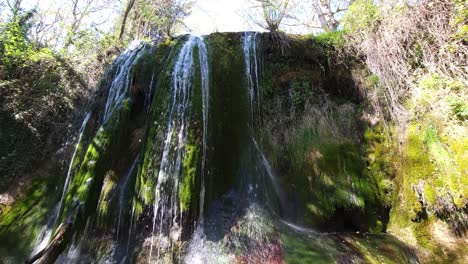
[390,122,464,261]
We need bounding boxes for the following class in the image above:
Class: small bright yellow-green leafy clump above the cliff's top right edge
[343,0,381,34]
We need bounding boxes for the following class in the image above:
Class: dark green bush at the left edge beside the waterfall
[0,19,87,191]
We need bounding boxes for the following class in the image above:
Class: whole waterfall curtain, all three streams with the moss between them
[11,32,422,264]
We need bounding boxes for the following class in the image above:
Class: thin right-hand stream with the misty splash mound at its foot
[183,32,280,264]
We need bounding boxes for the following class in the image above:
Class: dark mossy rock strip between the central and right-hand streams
[205,33,249,204]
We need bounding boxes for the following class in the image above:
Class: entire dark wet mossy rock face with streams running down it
[0,32,424,263]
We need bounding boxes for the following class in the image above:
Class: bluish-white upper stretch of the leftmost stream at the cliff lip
[104,40,144,123]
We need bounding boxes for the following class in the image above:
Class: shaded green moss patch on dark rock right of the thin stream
[291,124,385,230]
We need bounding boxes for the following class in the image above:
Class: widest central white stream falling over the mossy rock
[149,36,209,261]
